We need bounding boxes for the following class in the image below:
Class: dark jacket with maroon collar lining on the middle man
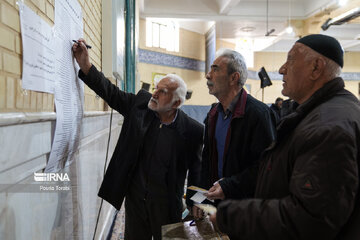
[200,89,275,199]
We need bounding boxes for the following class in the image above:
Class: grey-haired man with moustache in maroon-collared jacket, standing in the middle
[193,49,276,217]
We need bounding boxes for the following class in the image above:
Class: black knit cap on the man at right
[296,34,344,67]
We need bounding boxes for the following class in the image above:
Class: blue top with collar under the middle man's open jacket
[215,91,241,178]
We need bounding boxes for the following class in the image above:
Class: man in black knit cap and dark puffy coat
[211,34,360,240]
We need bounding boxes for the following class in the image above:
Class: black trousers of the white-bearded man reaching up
[125,196,170,240]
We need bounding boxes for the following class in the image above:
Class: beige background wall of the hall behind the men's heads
[139,19,360,105]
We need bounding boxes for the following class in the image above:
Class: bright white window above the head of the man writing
[146,18,179,52]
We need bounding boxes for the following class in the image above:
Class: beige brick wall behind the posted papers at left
[0,0,104,112]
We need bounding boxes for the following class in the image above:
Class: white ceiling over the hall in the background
[139,0,360,52]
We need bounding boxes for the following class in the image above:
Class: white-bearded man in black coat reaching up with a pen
[73,39,203,240]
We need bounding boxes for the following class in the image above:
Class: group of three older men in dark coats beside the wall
[72,34,360,240]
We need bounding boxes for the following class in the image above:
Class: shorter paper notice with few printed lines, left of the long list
[18,1,56,93]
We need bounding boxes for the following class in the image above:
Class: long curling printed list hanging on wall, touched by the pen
[45,0,84,172]
